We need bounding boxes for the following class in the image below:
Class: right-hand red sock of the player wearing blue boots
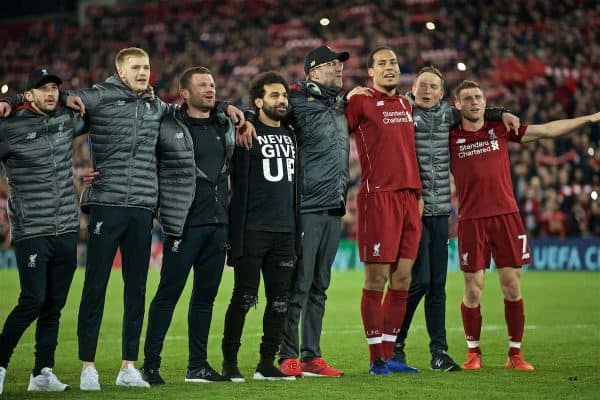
[382,287,408,360]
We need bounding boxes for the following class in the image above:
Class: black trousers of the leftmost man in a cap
[0,233,78,375]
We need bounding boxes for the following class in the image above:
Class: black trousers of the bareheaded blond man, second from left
[77,205,152,362]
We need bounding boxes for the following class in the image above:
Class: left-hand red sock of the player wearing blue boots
[360,289,383,363]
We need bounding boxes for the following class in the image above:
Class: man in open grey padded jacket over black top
[142,67,235,385]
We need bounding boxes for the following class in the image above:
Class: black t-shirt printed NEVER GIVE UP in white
[246,121,296,233]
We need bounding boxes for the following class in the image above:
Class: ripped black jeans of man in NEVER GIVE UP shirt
[221,231,296,364]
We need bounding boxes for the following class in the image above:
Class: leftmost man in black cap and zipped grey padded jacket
[0,68,86,393]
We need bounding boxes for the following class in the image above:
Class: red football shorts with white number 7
[458,213,531,272]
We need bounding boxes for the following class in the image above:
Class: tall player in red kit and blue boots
[346,47,422,375]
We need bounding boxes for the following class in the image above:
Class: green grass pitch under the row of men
[0,270,600,400]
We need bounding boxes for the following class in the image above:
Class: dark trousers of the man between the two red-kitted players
[396,215,448,354]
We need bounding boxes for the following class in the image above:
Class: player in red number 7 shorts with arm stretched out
[450,81,600,371]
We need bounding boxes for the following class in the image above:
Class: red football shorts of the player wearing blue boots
[356,190,423,263]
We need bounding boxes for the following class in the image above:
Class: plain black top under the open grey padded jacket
[187,116,228,226]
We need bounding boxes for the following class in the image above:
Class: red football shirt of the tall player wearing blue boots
[346,88,421,193]
